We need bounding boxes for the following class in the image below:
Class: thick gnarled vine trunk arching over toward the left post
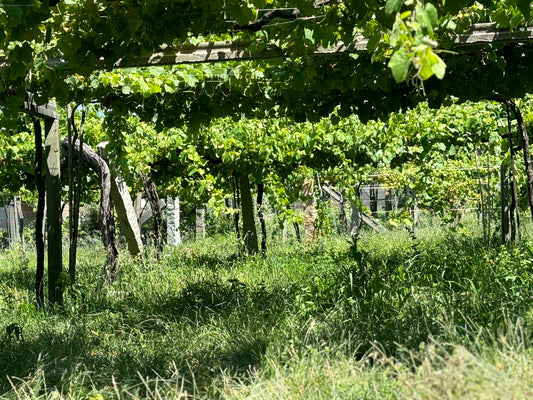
[62,140,119,283]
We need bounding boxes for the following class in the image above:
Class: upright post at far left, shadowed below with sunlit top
[44,118,63,303]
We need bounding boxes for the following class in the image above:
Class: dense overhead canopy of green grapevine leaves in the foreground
[0,0,533,126]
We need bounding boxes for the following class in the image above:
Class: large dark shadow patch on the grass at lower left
[0,280,286,395]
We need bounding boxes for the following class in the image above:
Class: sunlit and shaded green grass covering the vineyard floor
[0,223,533,399]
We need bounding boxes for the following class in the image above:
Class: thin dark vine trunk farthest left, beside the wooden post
[32,117,46,307]
